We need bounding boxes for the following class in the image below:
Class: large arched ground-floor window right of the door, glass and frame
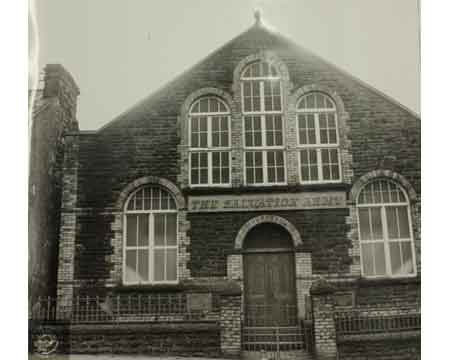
[357,179,416,277]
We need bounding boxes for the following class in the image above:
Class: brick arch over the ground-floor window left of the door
[116,176,186,210]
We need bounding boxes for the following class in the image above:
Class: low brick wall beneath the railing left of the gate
[30,322,221,357]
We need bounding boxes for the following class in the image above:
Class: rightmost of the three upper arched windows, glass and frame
[297,92,341,183]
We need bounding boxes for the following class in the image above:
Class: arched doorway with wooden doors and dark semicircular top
[243,223,297,327]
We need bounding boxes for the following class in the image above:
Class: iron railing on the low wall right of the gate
[335,312,420,335]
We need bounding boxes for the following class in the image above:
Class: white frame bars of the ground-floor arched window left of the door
[122,185,179,285]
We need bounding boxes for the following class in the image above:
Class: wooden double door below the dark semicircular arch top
[244,251,297,327]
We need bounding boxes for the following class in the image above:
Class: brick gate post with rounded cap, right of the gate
[310,280,337,360]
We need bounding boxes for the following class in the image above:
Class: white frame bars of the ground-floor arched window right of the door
[356,180,417,279]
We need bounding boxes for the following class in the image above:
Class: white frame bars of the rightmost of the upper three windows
[295,93,342,185]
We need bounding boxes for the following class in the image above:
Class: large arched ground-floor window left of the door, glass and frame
[123,186,178,284]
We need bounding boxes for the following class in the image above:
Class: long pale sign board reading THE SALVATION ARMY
[188,191,346,212]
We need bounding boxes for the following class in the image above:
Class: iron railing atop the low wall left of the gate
[30,293,219,323]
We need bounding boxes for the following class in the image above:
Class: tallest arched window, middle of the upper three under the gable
[241,61,286,185]
